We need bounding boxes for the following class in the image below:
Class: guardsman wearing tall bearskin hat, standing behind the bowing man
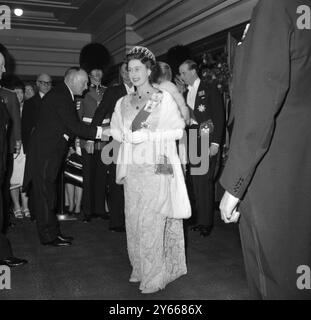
[77,43,110,222]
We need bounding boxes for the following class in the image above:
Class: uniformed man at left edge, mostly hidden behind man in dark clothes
[0,45,21,230]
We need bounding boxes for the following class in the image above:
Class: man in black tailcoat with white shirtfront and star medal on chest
[179,60,225,237]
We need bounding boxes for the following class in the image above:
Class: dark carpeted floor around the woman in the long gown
[0,215,248,300]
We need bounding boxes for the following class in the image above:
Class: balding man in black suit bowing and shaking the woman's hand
[24,68,106,246]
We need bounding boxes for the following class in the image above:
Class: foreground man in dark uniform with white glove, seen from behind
[220,0,311,299]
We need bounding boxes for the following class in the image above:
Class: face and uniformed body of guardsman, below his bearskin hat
[77,65,110,222]
